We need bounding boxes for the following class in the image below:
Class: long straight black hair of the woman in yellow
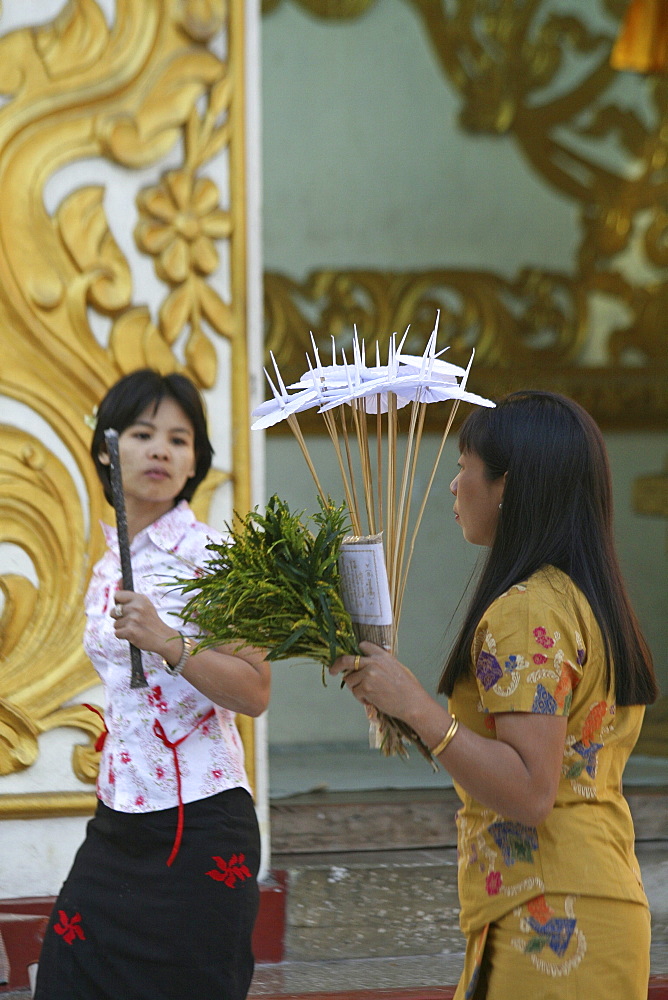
[439,391,659,705]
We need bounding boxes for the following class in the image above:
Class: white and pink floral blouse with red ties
[84,501,250,813]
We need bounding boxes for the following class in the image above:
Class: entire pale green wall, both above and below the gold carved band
[262,0,668,744]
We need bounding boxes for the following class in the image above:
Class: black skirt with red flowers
[35,788,260,1000]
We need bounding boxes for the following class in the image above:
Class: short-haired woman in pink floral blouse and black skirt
[35,369,270,1000]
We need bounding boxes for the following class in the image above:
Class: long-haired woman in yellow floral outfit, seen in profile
[332,392,658,1000]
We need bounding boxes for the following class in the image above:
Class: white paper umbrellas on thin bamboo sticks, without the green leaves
[252,314,494,633]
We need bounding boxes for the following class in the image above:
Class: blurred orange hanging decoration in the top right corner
[610,0,668,73]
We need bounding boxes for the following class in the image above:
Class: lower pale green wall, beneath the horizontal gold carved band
[266,434,668,744]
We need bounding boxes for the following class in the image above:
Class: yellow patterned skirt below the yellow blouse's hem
[454,894,650,1000]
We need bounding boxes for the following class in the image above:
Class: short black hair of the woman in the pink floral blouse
[90,368,213,504]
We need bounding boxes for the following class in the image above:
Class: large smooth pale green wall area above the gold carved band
[262,0,577,277]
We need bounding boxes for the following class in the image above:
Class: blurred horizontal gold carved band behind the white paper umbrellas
[265,269,668,435]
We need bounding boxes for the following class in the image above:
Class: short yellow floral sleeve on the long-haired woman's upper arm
[473,578,586,715]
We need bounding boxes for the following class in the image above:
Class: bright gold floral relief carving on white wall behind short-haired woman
[0,0,253,815]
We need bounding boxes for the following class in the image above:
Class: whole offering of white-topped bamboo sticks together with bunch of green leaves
[175,315,494,763]
